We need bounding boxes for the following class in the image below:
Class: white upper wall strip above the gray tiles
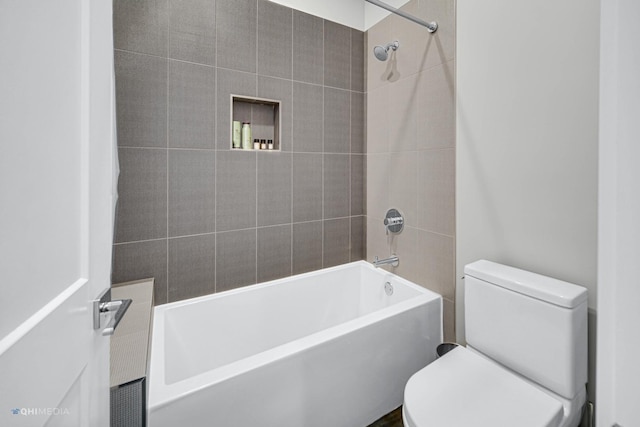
[270,0,408,31]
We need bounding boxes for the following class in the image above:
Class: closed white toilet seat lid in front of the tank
[403,347,563,427]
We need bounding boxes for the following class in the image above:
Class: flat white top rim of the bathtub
[147,260,444,413]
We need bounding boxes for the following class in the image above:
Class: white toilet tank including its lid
[464,260,588,399]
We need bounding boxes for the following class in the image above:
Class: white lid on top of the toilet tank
[464,260,587,308]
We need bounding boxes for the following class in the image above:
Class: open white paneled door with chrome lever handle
[0,0,114,427]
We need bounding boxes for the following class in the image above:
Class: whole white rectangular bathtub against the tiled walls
[148,261,442,427]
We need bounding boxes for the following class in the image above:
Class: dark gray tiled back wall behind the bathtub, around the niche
[113,0,364,304]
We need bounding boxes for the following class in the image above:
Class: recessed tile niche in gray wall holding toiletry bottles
[229,95,281,151]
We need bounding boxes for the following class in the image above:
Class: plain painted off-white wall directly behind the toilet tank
[456,0,600,398]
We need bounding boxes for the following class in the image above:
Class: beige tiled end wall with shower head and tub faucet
[366,0,455,341]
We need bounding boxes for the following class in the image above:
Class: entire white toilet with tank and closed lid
[402,260,588,427]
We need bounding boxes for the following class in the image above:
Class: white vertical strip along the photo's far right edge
[596,0,640,426]
